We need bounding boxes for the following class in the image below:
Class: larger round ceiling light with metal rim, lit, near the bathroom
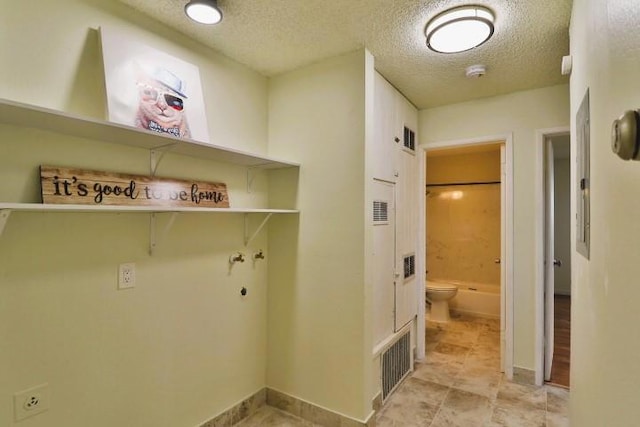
[425,6,494,53]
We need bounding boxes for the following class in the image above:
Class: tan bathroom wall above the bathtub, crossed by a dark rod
[426,149,500,287]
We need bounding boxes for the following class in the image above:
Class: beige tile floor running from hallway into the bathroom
[237,315,569,427]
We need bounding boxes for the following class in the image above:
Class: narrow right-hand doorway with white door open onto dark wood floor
[536,128,571,388]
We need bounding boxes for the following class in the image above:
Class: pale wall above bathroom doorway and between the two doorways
[419,85,569,370]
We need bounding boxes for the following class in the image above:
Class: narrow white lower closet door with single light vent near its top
[372,180,396,345]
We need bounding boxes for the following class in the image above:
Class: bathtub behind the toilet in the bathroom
[438,280,500,319]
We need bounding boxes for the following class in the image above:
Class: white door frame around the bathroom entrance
[416,133,514,380]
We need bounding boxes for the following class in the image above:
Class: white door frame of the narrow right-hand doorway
[534,126,573,385]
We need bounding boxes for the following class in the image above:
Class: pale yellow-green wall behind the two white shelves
[0,0,269,427]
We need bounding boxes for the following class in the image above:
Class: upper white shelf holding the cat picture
[0,98,300,169]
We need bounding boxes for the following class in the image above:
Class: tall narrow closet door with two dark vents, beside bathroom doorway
[395,93,424,331]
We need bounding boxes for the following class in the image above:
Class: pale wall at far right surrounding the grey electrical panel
[571,0,640,427]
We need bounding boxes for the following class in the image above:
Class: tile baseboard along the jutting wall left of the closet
[267,388,375,427]
